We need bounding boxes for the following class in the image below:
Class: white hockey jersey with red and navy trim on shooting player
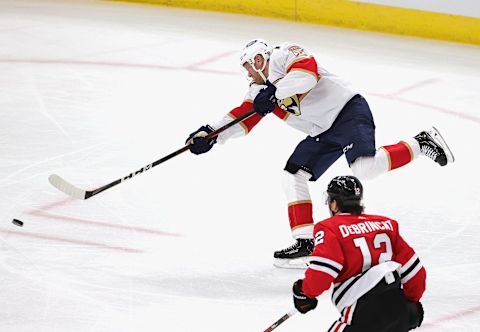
[213,43,358,143]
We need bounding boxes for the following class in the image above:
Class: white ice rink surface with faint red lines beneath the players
[0,0,480,332]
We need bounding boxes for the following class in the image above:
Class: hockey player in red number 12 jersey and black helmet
[293,176,426,332]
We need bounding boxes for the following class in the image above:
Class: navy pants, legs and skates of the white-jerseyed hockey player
[274,95,455,268]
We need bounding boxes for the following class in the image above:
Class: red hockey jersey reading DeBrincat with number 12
[303,214,426,311]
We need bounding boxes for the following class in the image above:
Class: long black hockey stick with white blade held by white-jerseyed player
[48,110,255,200]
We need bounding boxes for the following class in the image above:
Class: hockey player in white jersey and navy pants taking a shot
[187,39,454,267]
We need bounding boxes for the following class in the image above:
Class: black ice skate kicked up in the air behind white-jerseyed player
[414,127,455,166]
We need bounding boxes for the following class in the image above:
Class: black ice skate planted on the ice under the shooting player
[273,239,314,269]
